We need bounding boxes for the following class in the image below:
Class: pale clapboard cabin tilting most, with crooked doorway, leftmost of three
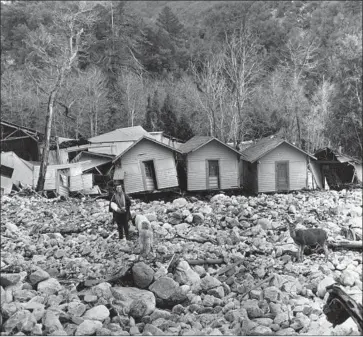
[112,136,179,194]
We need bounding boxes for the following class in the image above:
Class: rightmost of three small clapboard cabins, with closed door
[241,136,316,193]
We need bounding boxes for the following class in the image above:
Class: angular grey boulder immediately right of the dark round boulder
[149,277,187,308]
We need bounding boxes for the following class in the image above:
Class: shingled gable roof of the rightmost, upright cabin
[241,137,316,163]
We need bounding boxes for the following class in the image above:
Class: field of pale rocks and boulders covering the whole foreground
[0,189,362,336]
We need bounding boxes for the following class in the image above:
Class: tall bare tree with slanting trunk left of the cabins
[26,1,99,191]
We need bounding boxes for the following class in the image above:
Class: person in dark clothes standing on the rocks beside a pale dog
[109,185,131,240]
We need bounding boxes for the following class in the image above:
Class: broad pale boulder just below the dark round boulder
[111,287,156,315]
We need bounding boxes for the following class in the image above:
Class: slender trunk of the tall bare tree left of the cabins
[36,67,65,192]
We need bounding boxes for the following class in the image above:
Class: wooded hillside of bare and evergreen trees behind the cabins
[1,1,362,158]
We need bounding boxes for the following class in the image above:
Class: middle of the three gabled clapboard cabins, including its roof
[179,136,242,191]
